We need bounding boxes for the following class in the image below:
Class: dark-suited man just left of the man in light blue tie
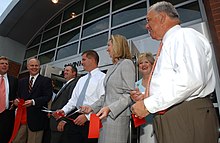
[50,64,79,143]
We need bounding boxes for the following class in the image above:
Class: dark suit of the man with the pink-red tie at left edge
[0,75,18,143]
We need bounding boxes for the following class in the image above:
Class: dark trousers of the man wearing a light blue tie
[61,113,98,143]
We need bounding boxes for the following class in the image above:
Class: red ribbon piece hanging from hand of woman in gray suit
[88,113,102,138]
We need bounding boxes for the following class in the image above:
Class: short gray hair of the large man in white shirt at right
[148,1,179,19]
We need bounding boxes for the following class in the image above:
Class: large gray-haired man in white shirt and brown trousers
[131,1,218,143]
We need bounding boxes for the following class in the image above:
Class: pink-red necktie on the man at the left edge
[0,75,6,113]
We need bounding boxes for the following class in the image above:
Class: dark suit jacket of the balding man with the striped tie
[18,75,53,131]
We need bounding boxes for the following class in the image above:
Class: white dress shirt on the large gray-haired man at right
[144,25,215,113]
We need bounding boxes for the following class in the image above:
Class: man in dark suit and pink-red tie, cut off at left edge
[0,56,18,143]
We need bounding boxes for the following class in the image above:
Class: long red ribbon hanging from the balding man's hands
[9,99,27,143]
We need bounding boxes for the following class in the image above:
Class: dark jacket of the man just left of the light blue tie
[50,77,79,131]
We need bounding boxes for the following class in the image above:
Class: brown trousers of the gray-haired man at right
[154,97,219,143]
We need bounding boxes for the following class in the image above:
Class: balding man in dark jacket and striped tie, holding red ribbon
[13,58,52,143]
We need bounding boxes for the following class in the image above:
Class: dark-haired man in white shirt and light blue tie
[54,50,105,143]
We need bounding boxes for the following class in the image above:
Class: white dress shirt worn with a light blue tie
[62,68,105,120]
